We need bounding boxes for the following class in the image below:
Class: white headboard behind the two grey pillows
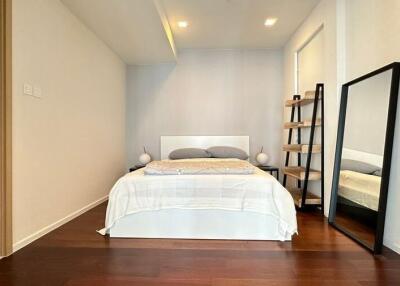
[160,136,250,160]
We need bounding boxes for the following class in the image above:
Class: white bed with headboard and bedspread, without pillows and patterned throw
[99,136,297,241]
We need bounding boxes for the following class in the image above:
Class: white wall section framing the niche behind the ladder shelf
[282,0,338,216]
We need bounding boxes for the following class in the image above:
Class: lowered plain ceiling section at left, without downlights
[61,0,175,64]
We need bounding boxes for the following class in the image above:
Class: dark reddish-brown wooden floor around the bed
[0,204,400,286]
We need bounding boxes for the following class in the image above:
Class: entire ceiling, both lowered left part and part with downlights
[61,0,319,64]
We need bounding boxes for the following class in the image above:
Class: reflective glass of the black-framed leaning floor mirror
[335,71,391,248]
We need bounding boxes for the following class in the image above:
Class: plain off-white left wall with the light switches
[13,0,125,249]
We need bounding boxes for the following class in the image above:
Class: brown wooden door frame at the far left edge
[0,0,12,256]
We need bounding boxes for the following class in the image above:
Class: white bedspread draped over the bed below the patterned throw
[99,161,297,239]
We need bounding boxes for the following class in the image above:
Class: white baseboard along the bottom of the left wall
[13,195,108,253]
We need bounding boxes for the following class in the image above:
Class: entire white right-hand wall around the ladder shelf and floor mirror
[284,0,400,252]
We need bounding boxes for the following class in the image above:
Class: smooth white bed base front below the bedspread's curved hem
[110,209,291,241]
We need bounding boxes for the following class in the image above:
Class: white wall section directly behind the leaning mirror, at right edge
[341,0,400,253]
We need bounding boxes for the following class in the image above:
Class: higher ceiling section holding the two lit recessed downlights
[163,0,319,49]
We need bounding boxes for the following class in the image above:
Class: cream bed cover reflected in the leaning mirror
[339,170,381,211]
